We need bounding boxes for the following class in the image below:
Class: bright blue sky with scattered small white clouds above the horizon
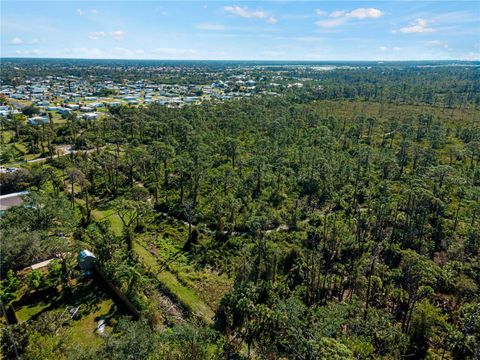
[0,0,480,60]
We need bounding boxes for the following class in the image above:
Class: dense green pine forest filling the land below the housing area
[0,66,480,359]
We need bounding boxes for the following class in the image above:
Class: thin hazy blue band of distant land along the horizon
[0,56,480,63]
